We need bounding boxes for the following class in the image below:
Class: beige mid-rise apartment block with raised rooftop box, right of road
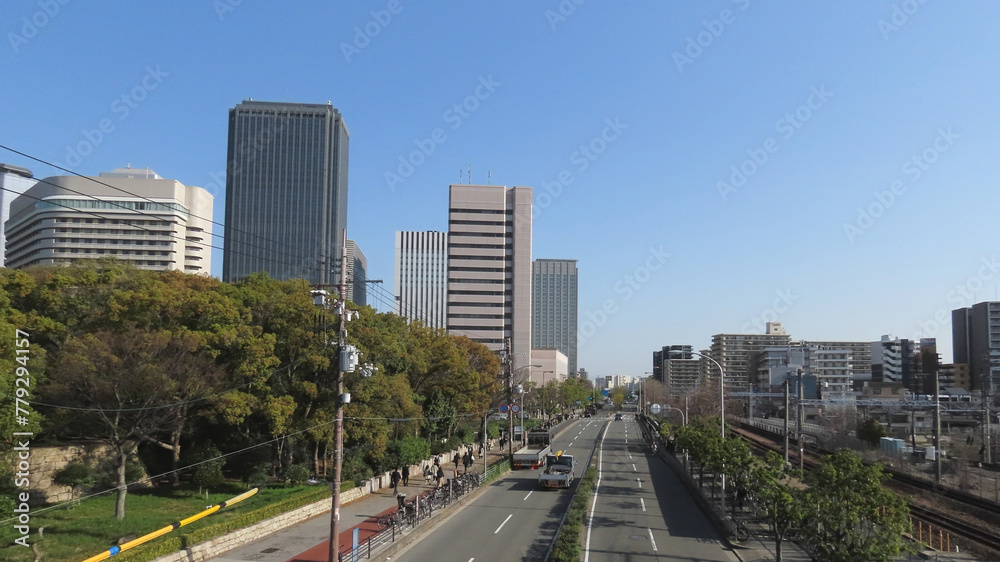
[704,322,791,392]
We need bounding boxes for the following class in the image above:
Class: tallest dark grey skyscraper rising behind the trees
[222,100,349,285]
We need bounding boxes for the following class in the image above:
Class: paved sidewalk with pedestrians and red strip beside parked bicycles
[212,447,504,562]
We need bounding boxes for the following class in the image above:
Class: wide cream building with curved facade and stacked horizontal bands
[5,168,213,275]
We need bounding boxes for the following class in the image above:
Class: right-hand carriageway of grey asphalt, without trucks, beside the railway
[584,413,738,562]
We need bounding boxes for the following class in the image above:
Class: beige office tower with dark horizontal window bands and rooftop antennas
[448,185,532,369]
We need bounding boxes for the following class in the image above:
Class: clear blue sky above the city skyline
[0,0,1000,375]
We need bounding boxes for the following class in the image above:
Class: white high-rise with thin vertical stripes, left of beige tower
[394,231,448,330]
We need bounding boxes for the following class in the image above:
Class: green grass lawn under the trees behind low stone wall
[0,484,330,562]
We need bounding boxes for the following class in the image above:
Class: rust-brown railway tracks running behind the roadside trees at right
[733,425,1000,560]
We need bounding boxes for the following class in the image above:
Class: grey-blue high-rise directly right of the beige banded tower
[531,259,578,373]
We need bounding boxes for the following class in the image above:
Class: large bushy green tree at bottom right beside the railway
[801,449,910,562]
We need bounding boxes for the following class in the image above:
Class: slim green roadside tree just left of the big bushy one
[750,451,805,562]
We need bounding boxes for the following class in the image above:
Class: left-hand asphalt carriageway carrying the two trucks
[393,416,604,562]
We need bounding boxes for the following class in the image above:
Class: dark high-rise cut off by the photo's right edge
[951,301,1000,398]
